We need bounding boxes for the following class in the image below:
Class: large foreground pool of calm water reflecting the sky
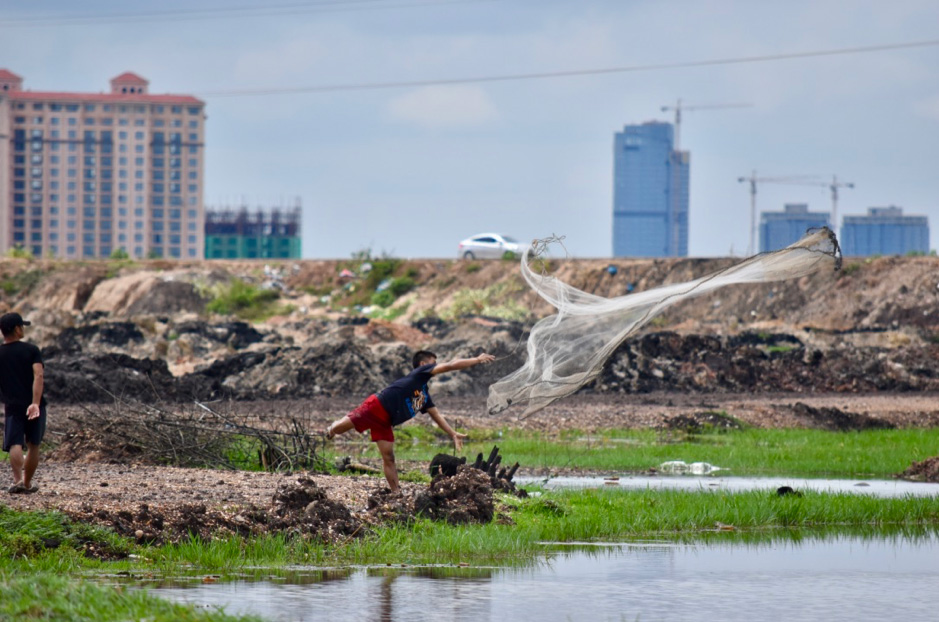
[151,535,939,622]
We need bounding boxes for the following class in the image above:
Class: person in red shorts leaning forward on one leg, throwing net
[326,350,495,491]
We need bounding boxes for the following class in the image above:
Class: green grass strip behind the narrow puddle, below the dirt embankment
[384,426,939,479]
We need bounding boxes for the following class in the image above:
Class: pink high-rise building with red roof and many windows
[0,69,205,259]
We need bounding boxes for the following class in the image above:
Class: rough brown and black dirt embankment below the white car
[0,257,939,410]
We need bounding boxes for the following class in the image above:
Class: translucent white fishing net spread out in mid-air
[487,227,841,417]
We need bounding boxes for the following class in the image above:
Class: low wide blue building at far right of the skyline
[841,205,929,256]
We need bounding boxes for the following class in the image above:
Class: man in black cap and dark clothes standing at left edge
[0,313,46,494]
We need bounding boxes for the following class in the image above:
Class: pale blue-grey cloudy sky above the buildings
[0,0,939,258]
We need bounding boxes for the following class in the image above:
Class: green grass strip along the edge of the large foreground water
[7,489,939,574]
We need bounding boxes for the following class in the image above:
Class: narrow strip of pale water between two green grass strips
[513,475,939,497]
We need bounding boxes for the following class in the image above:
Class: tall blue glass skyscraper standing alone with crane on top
[613,121,690,257]
